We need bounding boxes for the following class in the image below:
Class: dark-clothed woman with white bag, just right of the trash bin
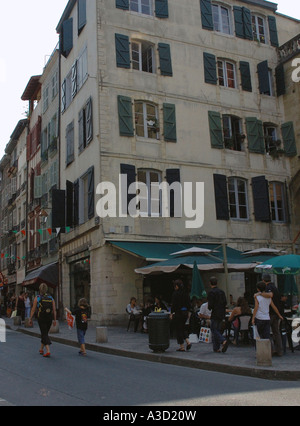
[171,280,192,352]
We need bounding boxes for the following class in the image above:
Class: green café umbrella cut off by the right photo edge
[255,254,300,275]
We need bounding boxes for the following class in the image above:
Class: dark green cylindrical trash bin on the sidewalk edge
[147,311,170,352]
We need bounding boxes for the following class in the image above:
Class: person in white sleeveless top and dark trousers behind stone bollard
[252,281,283,339]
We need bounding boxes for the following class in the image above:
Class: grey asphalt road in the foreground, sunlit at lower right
[0,331,300,408]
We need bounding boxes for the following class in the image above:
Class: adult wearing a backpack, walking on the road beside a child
[29,283,56,358]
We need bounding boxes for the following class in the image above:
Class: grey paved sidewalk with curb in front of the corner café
[3,318,300,381]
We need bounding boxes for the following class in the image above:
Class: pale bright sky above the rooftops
[0,0,300,159]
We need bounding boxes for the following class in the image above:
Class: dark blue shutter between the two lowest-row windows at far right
[252,176,271,222]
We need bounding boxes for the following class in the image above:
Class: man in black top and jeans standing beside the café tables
[208,277,229,353]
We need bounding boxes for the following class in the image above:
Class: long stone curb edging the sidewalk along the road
[7,326,300,382]
